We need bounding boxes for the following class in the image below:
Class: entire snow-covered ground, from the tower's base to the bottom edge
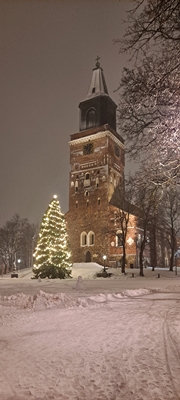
[0,264,180,400]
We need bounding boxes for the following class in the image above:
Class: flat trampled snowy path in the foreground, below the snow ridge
[0,291,180,400]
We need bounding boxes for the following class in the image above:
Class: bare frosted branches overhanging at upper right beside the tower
[115,0,180,185]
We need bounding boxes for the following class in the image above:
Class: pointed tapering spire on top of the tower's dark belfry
[86,57,108,99]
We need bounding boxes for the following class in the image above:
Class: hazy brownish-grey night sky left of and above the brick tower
[0,0,130,226]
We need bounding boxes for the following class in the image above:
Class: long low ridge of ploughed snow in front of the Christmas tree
[0,289,157,310]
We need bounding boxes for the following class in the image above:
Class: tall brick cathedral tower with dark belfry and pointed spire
[67,58,124,264]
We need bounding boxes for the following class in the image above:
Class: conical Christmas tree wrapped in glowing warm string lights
[33,196,72,279]
